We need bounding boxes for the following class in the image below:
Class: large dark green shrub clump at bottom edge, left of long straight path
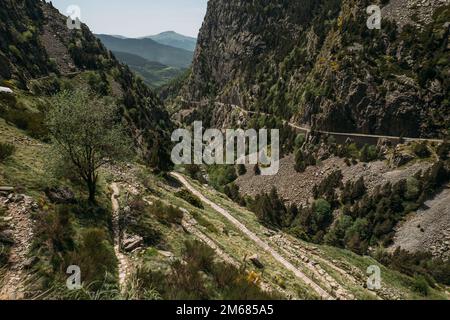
[129,241,278,300]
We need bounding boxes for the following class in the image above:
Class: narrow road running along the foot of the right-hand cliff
[182,100,444,143]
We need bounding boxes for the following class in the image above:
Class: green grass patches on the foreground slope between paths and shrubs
[0,95,446,299]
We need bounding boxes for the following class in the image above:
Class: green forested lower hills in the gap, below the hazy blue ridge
[113,51,184,87]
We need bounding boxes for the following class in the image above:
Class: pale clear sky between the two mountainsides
[48,0,208,37]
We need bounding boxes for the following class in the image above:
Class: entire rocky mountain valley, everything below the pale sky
[0,0,450,302]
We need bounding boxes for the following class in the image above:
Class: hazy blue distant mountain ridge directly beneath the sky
[96,34,193,68]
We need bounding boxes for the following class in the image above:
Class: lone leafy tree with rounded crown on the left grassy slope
[47,91,130,203]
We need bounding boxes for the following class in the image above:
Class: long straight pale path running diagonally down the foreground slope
[171,172,334,300]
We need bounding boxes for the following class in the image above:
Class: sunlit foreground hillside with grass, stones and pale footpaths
[0,115,446,300]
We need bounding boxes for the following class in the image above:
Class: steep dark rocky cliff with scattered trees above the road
[183,0,450,137]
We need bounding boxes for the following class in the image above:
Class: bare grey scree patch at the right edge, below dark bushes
[391,186,450,259]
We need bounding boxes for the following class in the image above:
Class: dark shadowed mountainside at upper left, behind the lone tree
[0,0,172,169]
